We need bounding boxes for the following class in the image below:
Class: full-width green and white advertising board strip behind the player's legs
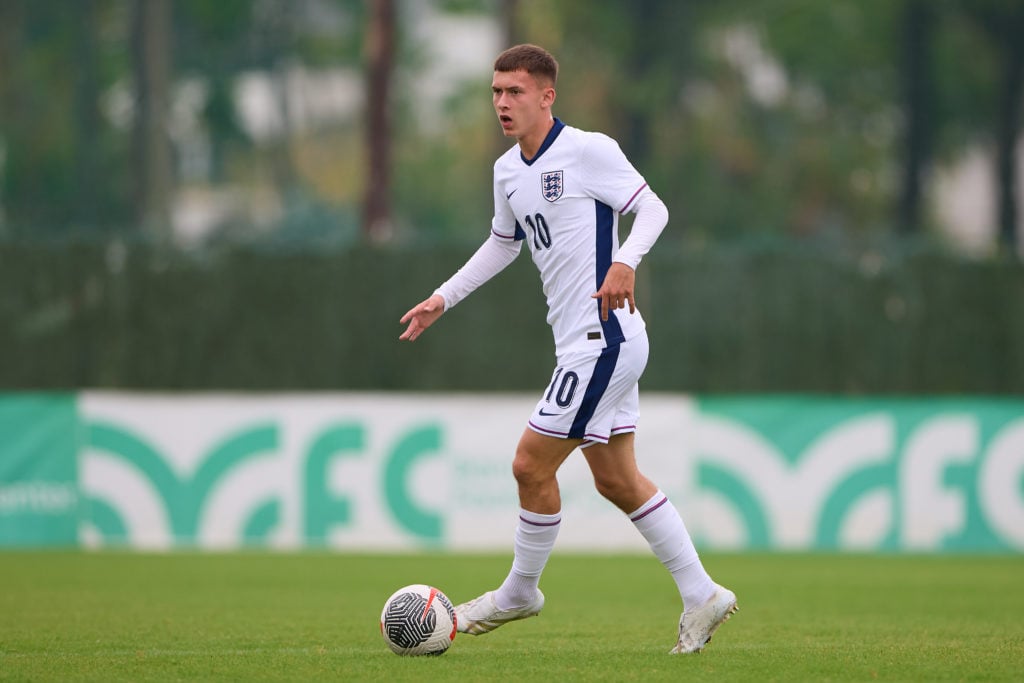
[0,394,1024,552]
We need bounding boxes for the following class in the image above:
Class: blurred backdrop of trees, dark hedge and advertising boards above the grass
[0,0,1024,552]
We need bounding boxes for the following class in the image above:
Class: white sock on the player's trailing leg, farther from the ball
[630,490,715,607]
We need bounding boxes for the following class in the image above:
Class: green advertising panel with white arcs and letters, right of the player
[695,397,1024,551]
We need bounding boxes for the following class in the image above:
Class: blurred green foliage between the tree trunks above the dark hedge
[0,0,1021,249]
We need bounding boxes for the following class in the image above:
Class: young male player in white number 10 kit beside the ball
[399,45,736,653]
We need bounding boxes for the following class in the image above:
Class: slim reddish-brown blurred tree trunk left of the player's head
[362,0,395,243]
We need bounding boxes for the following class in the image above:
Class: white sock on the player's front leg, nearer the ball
[495,509,562,609]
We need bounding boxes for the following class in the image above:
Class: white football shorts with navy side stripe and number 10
[528,332,649,447]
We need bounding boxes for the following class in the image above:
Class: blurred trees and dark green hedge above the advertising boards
[0,0,1024,395]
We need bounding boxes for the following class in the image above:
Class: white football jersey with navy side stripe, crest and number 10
[490,119,647,358]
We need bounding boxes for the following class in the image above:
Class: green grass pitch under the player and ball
[0,550,1024,682]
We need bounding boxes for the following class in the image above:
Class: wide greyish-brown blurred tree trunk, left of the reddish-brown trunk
[132,0,172,243]
